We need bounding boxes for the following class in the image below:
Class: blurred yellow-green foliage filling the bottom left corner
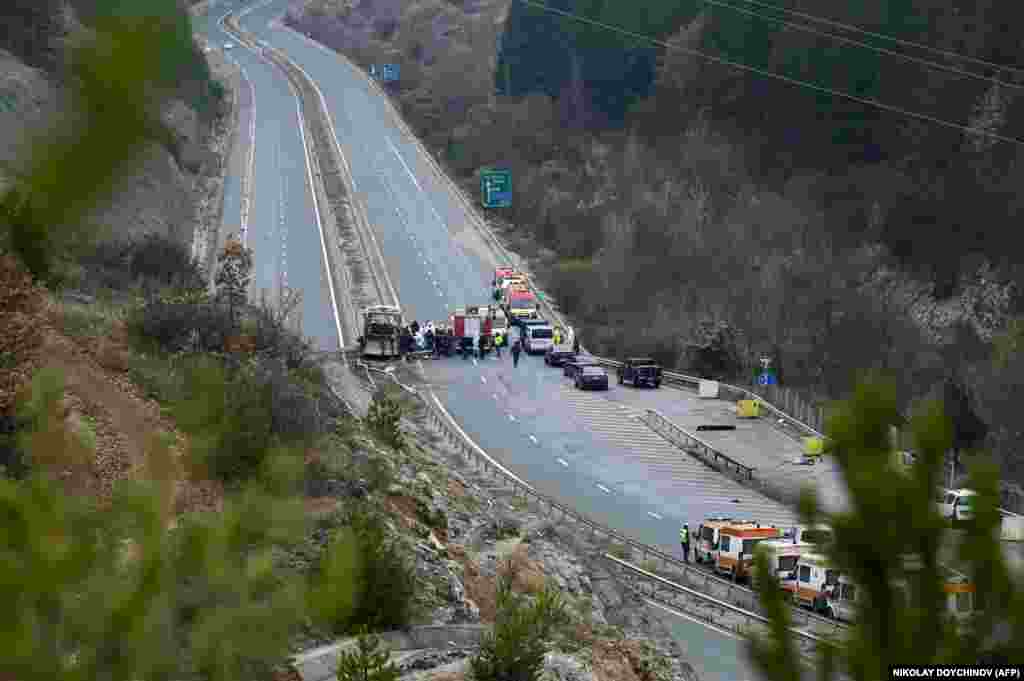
[0,358,358,681]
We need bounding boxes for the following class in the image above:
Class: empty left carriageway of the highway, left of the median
[198,4,338,350]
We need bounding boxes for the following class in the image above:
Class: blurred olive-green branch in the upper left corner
[0,0,220,285]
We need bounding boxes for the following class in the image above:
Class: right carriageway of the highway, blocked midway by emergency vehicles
[228,0,795,540]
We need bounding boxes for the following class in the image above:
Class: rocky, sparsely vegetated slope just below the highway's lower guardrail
[292,370,697,681]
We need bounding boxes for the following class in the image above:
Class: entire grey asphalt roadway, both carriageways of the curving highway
[193,0,782,680]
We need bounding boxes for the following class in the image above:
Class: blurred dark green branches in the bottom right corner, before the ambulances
[752,377,1024,681]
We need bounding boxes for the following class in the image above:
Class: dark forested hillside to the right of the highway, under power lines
[289,0,1024,489]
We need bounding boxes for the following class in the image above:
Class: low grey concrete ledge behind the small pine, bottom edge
[292,625,490,681]
